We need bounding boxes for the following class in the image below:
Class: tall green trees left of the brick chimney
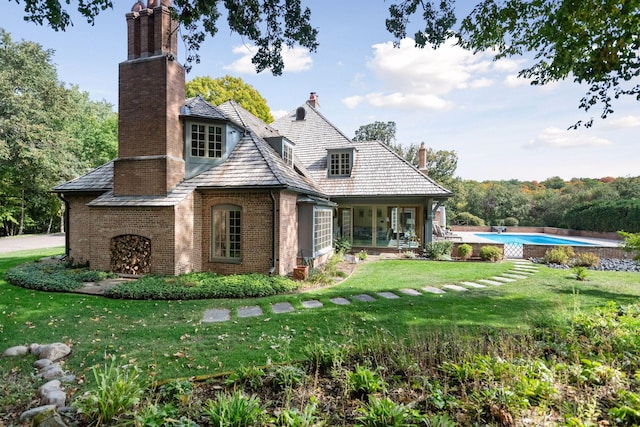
[0,28,118,235]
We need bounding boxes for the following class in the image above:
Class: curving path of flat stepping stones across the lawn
[202,261,539,323]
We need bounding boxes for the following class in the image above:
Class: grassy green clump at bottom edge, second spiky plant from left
[204,391,264,427]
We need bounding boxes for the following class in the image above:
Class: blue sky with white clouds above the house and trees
[0,0,640,181]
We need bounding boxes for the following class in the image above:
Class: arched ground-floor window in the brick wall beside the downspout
[211,205,242,261]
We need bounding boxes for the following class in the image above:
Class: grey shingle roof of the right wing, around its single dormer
[272,104,451,197]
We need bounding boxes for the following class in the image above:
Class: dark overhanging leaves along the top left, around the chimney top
[15,0,318,75]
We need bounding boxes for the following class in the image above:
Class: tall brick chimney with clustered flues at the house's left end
[113,0,185,196]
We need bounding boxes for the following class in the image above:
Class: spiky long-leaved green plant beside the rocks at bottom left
[74,357,146,425]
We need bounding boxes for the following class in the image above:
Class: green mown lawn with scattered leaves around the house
[0,249,640,379]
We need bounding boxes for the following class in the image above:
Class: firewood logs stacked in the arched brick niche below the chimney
[111,234,151,274]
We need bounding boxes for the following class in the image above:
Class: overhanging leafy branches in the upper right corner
[386,0,640,127]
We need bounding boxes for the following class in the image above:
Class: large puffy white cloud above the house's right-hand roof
[342,39,517,110]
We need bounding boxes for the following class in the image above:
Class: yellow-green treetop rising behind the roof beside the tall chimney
[186,76,273,123]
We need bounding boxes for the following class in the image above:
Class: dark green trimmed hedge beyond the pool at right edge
[564,199,640,233]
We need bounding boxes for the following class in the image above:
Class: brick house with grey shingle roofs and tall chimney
[54,0,451,274]
